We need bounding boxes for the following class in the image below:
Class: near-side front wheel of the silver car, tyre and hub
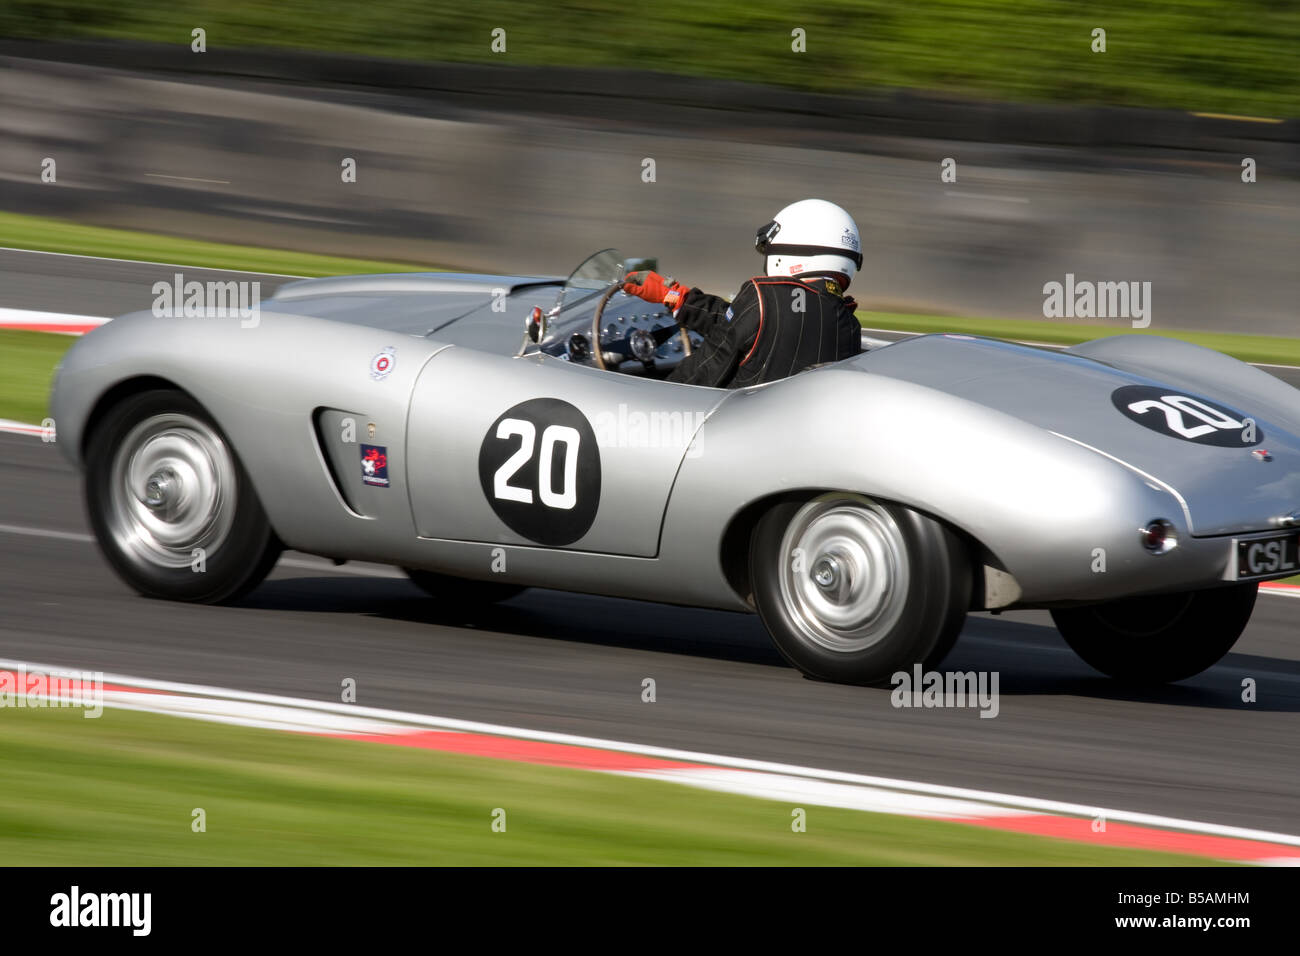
[86,389,282,604]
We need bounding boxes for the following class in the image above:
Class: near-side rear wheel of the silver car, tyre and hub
[750,493,971,684]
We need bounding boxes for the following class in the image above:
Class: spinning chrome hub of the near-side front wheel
[108,412,235,568]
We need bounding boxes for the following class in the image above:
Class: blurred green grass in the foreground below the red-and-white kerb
[0,708,1209,866]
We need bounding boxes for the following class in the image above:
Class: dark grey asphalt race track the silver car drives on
[0,254,1300,832]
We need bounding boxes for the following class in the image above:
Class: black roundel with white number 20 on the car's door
[478,398,601,545]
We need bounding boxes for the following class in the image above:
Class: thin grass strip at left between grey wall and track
[0,212,432,277]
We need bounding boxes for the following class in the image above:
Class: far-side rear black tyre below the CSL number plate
[1052,584,1258,684]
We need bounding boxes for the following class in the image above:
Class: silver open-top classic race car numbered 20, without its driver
[52,250,1300,683]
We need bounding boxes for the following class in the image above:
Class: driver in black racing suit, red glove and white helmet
[623,199,862,389]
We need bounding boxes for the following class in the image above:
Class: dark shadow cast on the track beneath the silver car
[241,578,1300,713]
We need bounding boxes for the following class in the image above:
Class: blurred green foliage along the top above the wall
[0,0,1300,117]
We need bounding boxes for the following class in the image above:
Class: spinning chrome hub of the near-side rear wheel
[780,494,909,653]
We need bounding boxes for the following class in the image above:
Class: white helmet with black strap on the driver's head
[754,199,862,286]
